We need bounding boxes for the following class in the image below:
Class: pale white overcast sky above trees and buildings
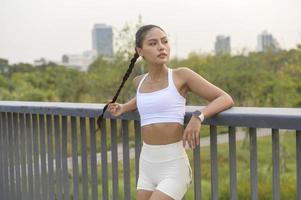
[0,0,301,63]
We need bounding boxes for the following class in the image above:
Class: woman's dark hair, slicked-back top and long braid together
[97,24,164,128]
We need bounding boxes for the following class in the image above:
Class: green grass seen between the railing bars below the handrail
[62,127,296,200]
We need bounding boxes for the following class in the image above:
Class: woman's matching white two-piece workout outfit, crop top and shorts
[136,68,192,200]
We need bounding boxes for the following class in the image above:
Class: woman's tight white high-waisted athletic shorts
[137,141,192,200]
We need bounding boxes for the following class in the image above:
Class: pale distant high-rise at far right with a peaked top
[257,30,280,52]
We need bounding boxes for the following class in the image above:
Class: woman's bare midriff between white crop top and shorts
[142,122,183,145]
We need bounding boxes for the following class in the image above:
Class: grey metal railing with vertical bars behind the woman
[0,101,301,200]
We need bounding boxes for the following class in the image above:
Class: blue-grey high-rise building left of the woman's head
[92,24,113,57]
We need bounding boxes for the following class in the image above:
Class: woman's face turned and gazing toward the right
[137,28,170,64]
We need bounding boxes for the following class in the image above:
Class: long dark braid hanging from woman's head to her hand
[97,51,139,128]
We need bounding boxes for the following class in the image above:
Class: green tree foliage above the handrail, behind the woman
[0,24,301,107]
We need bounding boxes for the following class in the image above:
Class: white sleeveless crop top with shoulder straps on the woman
[136,68,186,126]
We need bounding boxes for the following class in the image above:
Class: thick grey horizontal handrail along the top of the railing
[0,101,301,130]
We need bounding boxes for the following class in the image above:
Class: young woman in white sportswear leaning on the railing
[104,25,234,200]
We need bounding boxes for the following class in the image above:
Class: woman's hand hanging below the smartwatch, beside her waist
[183,116,201,149]
